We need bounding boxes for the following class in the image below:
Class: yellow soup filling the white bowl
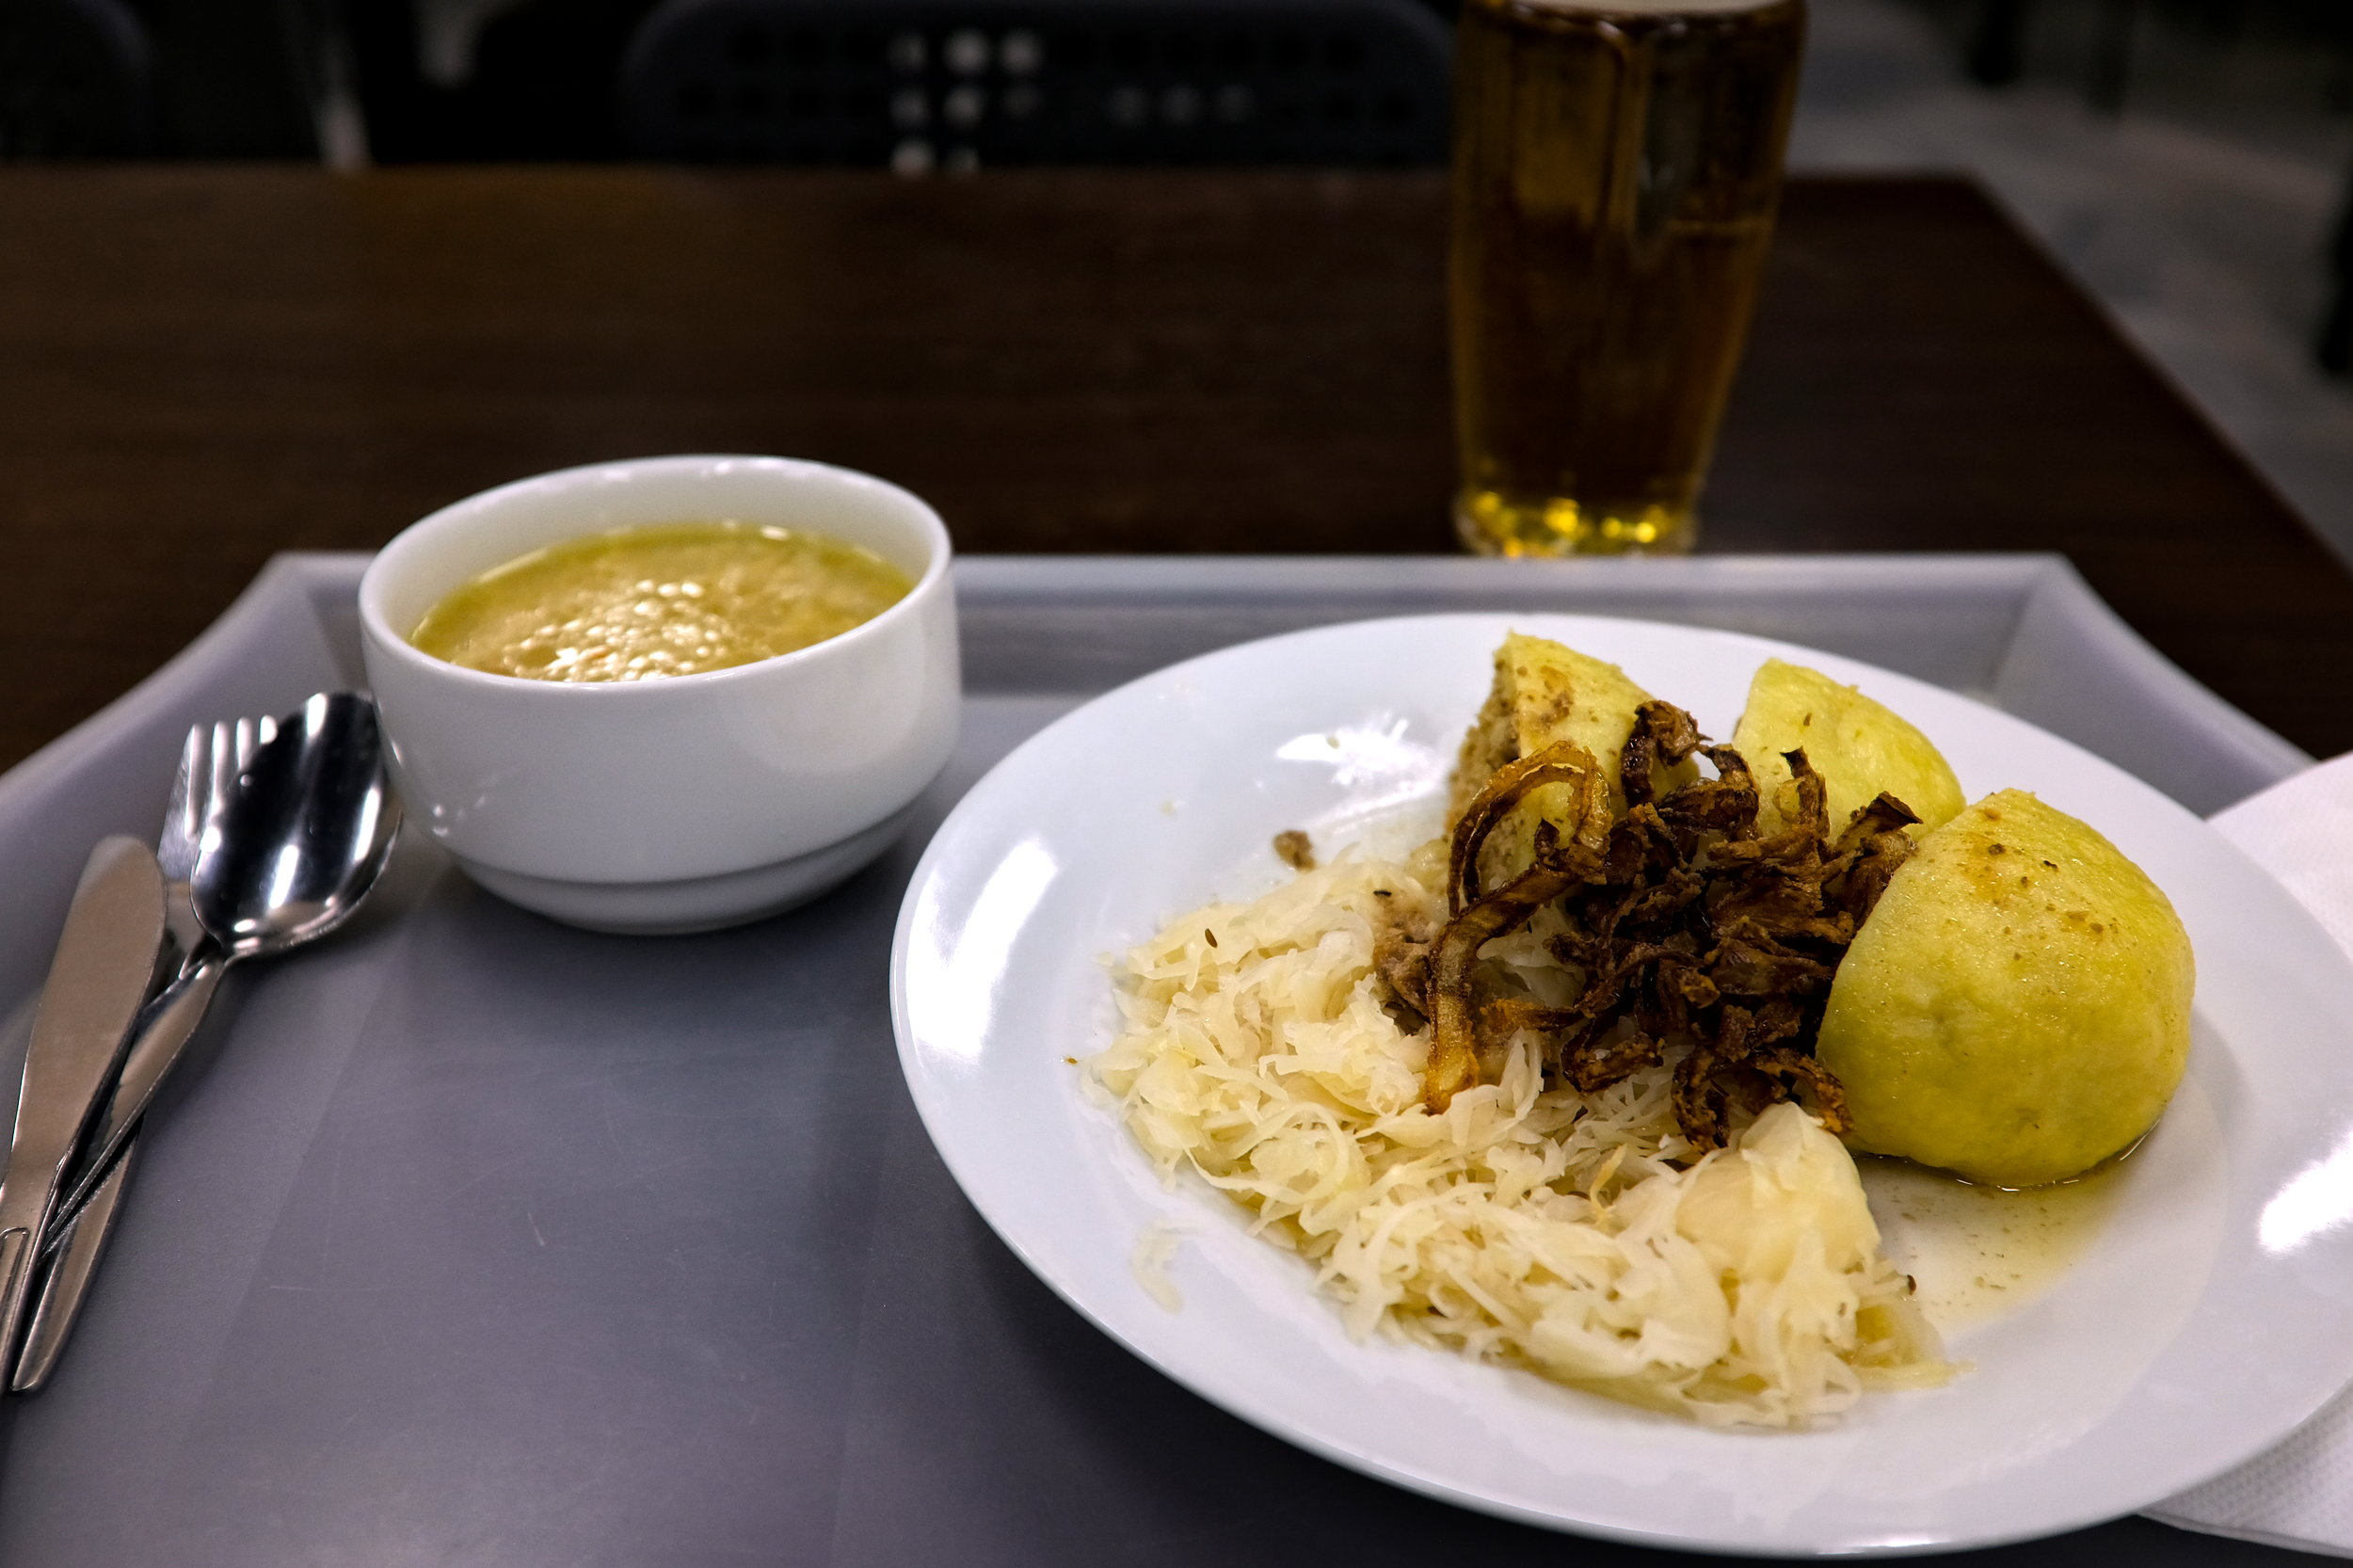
[409,522,913,680]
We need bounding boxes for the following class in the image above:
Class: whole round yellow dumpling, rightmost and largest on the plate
[1817,789,2196,1187]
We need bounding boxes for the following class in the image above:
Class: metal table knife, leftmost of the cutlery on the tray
[0,836,165,1366]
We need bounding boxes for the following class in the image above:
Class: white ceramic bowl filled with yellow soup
[360,456,960,933]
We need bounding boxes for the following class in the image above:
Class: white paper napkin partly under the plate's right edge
[2149,756,2353,1556]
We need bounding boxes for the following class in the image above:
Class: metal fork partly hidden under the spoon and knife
[9,718,264,1394]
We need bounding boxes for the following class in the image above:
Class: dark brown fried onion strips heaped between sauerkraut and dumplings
[1412,701,1918,1149]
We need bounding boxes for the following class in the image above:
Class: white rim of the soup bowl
[358,452,955,701]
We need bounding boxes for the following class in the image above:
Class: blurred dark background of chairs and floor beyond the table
[0,0,2353,560]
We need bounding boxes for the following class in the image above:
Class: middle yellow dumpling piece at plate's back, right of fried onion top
[1732,659,1962,839]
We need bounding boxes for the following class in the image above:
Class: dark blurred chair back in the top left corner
[0,0,153,158]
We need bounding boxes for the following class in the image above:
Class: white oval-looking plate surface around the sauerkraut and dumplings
[892,615,2353,1554]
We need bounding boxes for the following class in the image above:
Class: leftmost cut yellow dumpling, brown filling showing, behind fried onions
[1448,631,1699,888]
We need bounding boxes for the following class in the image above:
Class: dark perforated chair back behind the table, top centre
[621,0,1449,172]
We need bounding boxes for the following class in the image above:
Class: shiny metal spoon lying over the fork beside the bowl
[42,692,400,1250]
